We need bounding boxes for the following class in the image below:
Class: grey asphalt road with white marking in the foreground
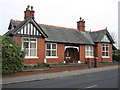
[3,69,118,89]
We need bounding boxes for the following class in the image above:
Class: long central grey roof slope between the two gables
[40,25,94,44]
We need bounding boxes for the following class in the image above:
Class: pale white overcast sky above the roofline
[0,0,120,47]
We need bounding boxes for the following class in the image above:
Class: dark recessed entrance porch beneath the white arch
[65,48,79,63]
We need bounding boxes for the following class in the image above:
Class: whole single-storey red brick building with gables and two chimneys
[5,6,114,64]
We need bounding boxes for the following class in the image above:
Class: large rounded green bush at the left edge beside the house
[0,36,25,74]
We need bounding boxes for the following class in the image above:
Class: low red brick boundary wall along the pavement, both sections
[2,64,118,78]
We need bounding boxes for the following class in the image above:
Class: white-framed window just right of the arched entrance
[85,45,94,58]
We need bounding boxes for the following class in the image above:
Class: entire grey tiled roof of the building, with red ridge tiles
[5,17,114,45]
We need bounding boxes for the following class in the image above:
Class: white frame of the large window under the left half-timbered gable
[22,37,38,59]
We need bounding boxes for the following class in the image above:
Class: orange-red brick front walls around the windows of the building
[12,36,112,64]
